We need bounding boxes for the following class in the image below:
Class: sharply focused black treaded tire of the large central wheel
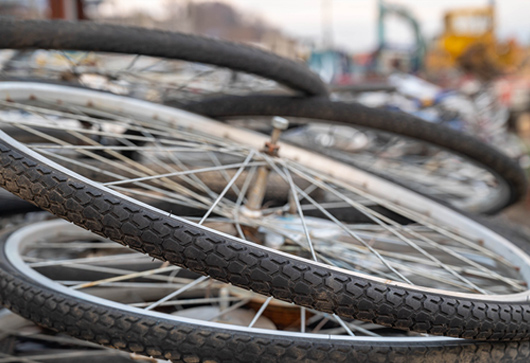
[0,88,530,340]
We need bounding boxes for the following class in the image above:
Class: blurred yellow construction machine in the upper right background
[426,5,522,75]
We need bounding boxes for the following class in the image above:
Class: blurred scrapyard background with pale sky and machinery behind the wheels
[0,0,530,218]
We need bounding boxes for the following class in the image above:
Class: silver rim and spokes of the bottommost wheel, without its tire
[4,220,462,344]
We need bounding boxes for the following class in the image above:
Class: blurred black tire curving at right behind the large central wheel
[184,95,528,214]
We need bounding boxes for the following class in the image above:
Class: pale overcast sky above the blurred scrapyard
[102,0,530,52]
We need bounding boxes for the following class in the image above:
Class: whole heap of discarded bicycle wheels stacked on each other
[0,21,530,362]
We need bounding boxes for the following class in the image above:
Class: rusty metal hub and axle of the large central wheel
[244,116,289,215]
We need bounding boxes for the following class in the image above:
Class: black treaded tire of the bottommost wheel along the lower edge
[0,222,530,362]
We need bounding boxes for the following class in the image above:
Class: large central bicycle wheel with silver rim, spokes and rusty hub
[0,83,530,340]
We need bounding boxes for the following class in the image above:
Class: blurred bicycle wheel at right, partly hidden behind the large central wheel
[185,96,527,214]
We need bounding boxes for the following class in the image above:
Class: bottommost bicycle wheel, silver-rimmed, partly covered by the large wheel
[0,220,530,362]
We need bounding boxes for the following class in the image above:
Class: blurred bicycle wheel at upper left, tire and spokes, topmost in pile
[0,20,327,102]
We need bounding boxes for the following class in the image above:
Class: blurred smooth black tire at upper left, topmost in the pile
[0,20,327,95]
